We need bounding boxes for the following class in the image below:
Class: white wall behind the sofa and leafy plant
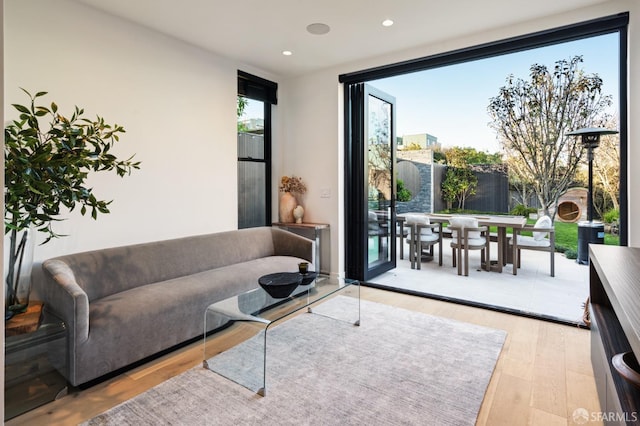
[4,0,276,260]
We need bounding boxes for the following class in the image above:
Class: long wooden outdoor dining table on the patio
[397,213,527,272]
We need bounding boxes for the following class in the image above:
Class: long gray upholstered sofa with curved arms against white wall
[39,227,313,386]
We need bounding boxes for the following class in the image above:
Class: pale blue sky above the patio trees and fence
[369,33,619,153]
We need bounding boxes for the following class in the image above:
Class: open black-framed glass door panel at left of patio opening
[345,84,396,280]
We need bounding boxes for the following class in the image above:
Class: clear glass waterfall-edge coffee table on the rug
[202,274,360,396]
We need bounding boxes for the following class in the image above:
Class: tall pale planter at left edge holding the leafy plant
[4,228,35,318]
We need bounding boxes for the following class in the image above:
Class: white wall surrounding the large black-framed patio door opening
[280,0,640,272]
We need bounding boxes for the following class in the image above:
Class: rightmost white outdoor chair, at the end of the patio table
[513,215,556,277]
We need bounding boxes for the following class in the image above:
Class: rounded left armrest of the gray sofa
[42,259,89,347]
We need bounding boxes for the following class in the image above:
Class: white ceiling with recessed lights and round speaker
[75,0,612,76]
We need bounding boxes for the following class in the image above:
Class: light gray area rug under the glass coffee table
[84,296,506,426]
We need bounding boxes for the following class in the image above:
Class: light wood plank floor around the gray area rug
[7,287,600,426]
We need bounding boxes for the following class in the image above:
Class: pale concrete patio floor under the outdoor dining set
[369,239,589,324]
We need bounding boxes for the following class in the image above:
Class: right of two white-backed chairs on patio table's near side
[449,216,491,276]
